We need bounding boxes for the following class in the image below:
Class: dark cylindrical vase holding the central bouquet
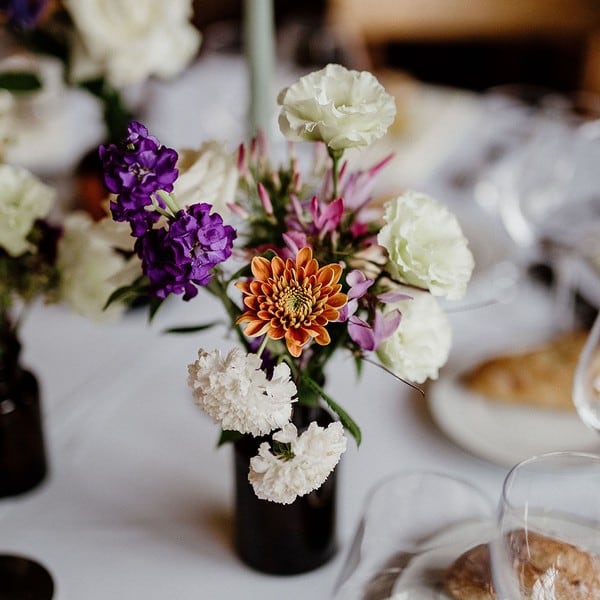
[234,406,337,575]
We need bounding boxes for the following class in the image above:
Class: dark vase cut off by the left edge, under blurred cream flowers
[0,334,47,497]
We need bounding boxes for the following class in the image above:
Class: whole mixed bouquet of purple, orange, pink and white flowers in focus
[100,65,473,504]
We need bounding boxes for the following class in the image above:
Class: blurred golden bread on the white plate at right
[461,330,600,410]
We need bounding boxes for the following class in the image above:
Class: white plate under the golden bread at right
[427,373,600,467]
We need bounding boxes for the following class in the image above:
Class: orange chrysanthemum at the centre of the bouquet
[236,248,348,357]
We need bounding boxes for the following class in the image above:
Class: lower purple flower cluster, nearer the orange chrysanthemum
[135,203,236,300]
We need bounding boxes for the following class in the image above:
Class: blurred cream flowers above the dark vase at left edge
[0,163,126,344]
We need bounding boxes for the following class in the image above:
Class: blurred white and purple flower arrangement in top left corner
[0,0,201,139]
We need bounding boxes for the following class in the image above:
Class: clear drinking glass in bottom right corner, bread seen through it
[490,452,600,600]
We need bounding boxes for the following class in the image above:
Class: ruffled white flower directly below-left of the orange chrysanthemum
[188,348,296,436]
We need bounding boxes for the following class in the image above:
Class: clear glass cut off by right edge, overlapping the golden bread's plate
[573,313,600,432]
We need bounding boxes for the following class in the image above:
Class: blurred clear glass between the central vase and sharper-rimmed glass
[334,471,494,600]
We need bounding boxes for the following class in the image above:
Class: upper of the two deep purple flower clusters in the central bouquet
[99,121,178,237]
